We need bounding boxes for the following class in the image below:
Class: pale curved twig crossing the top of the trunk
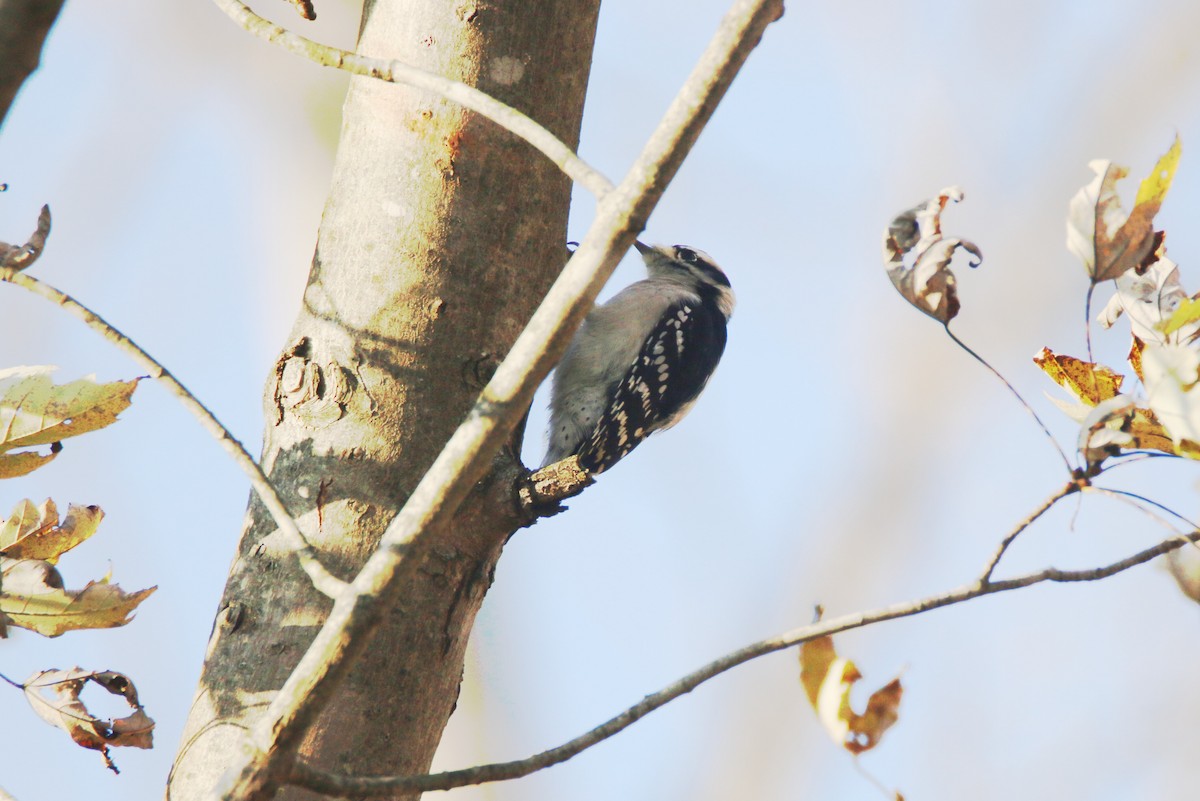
[214,0,613,198]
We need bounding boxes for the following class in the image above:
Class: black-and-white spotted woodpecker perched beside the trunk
[542,241,734,474]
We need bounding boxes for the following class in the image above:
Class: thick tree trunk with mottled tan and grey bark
[168,0,599,800]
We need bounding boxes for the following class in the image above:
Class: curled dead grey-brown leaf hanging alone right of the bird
[883,186,983,325]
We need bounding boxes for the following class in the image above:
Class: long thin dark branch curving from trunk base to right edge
[289,531,1200,797]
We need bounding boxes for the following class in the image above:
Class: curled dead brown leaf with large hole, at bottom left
[23,668,155,773]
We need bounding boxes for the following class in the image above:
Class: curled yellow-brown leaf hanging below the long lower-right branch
[800,637,904,754]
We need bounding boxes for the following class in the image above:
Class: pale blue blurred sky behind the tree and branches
[0,0,1200,801]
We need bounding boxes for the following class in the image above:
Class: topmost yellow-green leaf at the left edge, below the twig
[0,367,139,477]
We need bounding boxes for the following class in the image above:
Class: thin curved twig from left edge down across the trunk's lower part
[0,270,347,598]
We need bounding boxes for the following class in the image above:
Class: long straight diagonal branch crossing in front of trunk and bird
[222,0,782,801]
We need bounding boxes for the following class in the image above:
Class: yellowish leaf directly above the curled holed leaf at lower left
[0,558,157,637]
